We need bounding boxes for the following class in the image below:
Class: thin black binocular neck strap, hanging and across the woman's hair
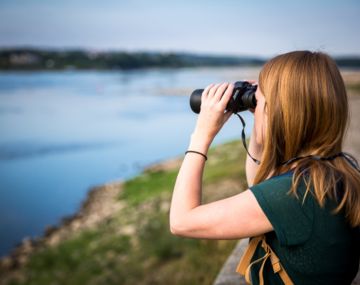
[235,113,360,172]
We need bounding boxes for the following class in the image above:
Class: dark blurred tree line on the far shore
[0,48,360,70]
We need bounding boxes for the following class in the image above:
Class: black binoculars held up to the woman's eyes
[190,81,257,114]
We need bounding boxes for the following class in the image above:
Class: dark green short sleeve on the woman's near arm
[250,175,314,246]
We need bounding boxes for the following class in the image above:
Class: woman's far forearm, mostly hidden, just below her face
[245,126,262,187]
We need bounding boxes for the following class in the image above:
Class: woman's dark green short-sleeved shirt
[250,172,360,285]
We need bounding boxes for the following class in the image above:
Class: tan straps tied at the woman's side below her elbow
[236,235,294,285]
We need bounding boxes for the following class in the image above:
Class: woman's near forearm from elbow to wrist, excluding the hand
[170,134,211,228]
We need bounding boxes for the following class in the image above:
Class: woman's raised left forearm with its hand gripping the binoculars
[170,83,234,234]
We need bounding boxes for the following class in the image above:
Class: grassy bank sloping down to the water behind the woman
[0,141,246,285]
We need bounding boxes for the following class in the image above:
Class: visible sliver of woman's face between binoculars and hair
[254,87,267,145]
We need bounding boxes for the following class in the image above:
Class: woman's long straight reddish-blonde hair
[254,51,360,227]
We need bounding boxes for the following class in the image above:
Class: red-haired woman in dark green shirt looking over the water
[170,51,360,285]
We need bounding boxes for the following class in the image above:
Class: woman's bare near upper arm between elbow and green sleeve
[172,190,273,239]
